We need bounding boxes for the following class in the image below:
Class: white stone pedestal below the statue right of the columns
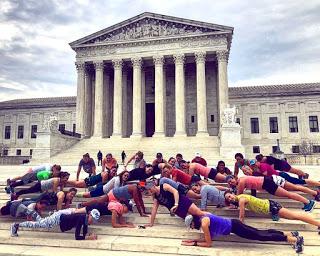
[219,123,244,159]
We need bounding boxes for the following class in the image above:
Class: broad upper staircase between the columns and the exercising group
[41,136,221,166]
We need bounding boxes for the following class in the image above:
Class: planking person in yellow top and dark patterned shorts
[224,191,320,232]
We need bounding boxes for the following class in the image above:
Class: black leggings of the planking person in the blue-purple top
[231,219,287,241]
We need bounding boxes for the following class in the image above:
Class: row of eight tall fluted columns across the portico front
[76,51,228,137]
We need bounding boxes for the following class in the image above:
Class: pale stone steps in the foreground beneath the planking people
[0,181,320,256]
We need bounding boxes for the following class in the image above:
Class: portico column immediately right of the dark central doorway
[153,56,166,137]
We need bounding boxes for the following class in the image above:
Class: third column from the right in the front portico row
[173,54,187,136]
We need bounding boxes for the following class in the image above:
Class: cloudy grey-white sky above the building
[0,0,320,101]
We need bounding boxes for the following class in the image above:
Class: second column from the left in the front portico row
[93,61,105,137]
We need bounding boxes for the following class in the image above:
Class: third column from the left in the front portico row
[112,59,123,137]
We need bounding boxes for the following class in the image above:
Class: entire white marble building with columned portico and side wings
[0,13,320,161]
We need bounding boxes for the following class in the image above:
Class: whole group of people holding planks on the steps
[1,151,320,252]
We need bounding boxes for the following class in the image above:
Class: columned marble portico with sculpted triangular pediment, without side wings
[70,13,233,137]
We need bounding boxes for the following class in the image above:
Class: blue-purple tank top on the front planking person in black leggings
[202,213,231,239]
